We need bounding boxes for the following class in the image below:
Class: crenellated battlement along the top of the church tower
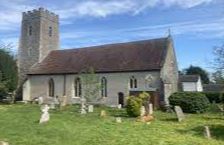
[23,7,59,22]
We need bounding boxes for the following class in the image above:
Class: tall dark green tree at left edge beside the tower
[0,45,18,98]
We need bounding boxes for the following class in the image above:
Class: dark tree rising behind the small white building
[183,65,209,84]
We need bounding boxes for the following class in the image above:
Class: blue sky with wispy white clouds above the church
[0,0,224,71]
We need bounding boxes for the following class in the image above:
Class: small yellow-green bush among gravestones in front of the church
[126,96,142,117]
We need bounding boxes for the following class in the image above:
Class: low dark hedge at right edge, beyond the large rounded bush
[204,92,223,103]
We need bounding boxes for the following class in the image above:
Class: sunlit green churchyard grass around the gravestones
[0,104,224,145]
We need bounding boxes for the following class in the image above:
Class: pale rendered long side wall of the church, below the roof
[24,71,160,105]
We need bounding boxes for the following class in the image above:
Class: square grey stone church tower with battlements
[18,8,59,84]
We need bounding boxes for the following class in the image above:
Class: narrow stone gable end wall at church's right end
[161,37,178,104]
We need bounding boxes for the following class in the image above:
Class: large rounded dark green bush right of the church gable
[169,92,209,113]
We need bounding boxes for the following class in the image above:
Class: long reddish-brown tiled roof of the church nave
[29,38,168,74]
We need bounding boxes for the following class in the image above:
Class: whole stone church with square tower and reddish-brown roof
[18,8,178,106]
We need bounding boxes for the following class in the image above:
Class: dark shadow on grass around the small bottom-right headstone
[177,125,224,141]
